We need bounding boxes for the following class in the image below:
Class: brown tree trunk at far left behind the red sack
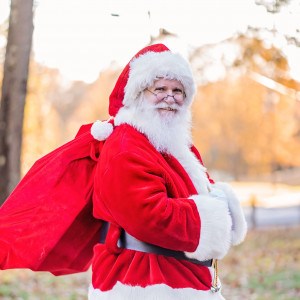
[0,0,33,205]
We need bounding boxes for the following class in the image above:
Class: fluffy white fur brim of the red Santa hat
[123,51,196,106]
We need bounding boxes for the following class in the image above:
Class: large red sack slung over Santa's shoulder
[0,125,103,275]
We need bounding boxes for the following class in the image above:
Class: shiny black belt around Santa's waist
[99,221,212,267]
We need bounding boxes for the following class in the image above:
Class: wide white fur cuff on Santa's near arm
[185,195,232,260]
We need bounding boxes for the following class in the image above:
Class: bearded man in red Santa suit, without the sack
[89,45,246,300]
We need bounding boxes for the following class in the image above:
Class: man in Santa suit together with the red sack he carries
[0,44,247,300]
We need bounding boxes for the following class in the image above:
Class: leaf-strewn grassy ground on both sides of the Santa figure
[0,227,300,300]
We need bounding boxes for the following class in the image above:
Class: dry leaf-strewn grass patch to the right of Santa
[219,227,300,300]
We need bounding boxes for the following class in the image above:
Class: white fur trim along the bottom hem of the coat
[88,282,225,300]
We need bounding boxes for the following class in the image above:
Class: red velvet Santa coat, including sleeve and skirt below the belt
[90,124,232,299]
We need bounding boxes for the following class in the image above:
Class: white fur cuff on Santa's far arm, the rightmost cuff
[215,182,247,245]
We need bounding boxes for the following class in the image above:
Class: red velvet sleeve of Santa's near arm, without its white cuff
[99,152,200,251]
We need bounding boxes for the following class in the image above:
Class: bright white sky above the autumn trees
[0,0,300,82]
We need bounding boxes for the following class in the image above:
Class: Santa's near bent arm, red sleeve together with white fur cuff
[99,153,231,259]
